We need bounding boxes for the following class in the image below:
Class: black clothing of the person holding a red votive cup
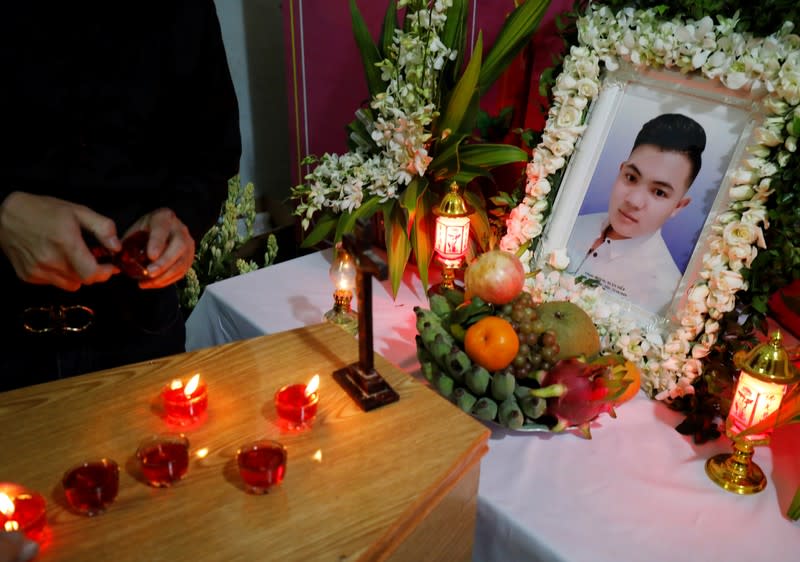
[0,0,241,390]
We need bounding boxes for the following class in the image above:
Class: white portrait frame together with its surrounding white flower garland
[500,3,800,401]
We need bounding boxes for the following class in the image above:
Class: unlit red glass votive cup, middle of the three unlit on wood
[136,433,189,488]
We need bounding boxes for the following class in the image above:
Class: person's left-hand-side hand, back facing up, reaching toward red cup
[0,191,121,291]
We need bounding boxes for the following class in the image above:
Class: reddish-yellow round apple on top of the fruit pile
[464,250,525,304]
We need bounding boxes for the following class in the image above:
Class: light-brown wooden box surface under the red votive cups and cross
[0,324,489,562]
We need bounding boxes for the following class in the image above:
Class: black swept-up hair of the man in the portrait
[633,113,706,188]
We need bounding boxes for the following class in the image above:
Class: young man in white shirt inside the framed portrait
[567,113,706,315]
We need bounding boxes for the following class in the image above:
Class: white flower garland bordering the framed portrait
[500,4,800,400]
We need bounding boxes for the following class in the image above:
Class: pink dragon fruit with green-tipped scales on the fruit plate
[531,358,630,439]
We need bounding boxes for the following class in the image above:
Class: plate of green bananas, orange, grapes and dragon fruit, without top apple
[414,290,625,438]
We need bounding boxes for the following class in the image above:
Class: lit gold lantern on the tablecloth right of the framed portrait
[706,332,800,494]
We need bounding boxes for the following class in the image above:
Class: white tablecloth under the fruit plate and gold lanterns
[187,252,800,562]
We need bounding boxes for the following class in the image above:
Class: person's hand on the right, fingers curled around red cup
[125,208,194,289]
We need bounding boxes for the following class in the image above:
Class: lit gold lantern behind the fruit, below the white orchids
[430,182,473,293]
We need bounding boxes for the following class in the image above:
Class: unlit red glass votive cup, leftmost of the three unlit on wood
[61,459,119,517]
